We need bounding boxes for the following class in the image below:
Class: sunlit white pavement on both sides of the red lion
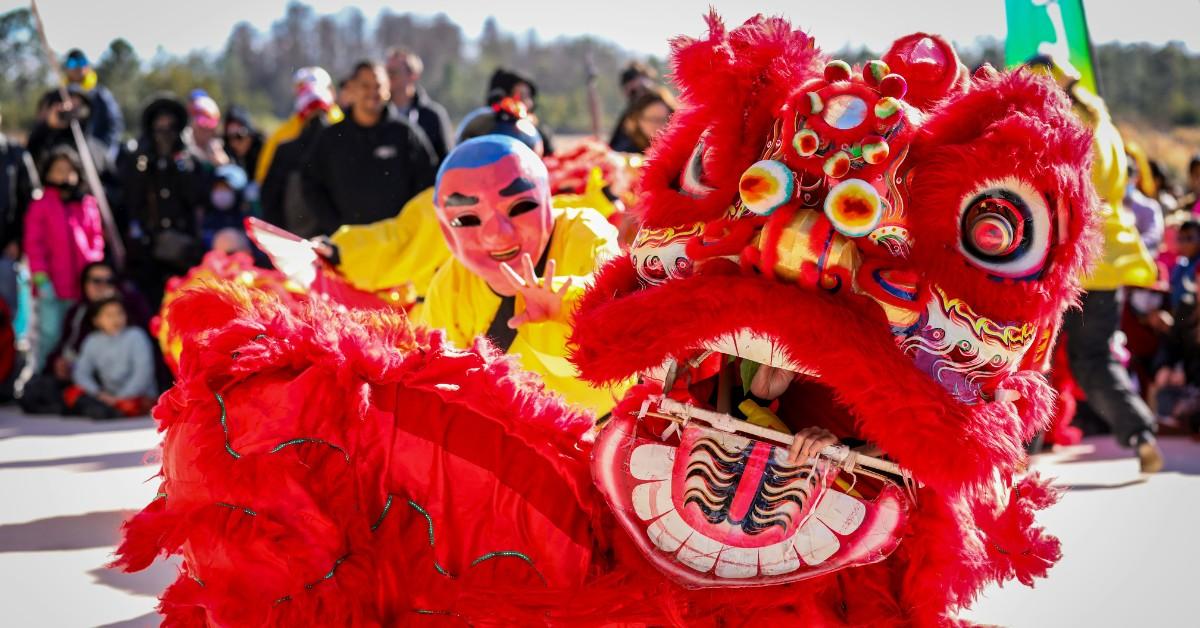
[0,407,1200,628]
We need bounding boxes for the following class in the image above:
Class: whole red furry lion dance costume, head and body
[119,16,1094,626]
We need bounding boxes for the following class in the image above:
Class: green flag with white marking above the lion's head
[1004,0,1099,94]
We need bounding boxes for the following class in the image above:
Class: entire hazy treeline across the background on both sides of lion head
[0,2,1200,137]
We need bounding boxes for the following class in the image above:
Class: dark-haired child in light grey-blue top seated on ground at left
[66,297,158,419]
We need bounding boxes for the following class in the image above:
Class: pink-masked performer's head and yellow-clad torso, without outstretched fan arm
[415,134,623,414]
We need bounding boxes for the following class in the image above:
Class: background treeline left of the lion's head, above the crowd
[0,2,661,137]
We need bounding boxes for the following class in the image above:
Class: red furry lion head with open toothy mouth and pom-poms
[572,13,1096,598]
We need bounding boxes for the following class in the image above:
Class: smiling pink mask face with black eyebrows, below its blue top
[436,152,553,295]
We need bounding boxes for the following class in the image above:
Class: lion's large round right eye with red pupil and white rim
[959,179,1050,279]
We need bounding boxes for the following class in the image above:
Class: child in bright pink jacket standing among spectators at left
[24,146,104,367]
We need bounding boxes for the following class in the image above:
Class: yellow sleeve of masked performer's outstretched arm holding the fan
[330,187,450,297]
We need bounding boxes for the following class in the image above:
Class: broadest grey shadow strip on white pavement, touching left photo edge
[0,510,132,552]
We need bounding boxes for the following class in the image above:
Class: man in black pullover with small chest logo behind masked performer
[304,61,437,234]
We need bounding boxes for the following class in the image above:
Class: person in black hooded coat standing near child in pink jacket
[122,97,211,310]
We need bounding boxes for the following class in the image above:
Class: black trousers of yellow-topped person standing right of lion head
[1062,291,1154,447]
